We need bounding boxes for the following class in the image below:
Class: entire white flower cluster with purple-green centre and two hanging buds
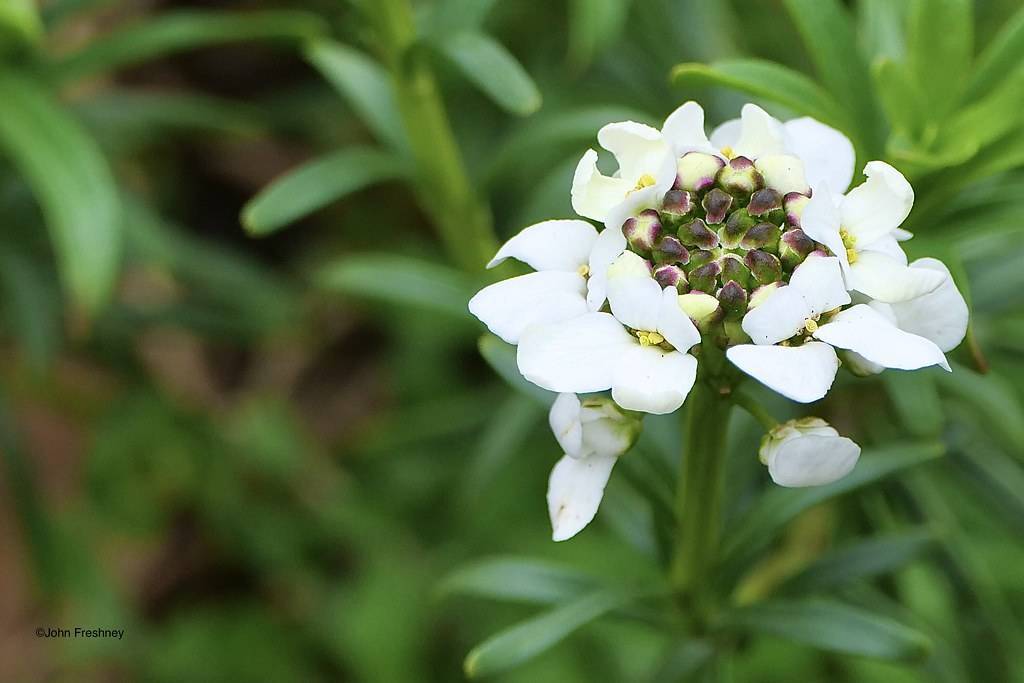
[469,102,968,540]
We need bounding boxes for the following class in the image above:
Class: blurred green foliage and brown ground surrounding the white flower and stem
[0,0,1024,682]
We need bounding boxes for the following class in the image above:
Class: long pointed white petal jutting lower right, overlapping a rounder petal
[814,303,949,370]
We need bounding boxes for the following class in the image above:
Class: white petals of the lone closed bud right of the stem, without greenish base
[768,430,860,486]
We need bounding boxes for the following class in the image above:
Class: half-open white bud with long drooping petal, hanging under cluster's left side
[548,393,640,541]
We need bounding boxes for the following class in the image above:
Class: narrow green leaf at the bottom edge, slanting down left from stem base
[463,590,630,678]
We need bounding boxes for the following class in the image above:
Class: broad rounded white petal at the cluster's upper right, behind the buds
[782,117,855,193]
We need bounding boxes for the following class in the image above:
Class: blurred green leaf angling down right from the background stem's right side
[433,31,541,116]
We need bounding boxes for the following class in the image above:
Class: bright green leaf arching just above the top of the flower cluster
[671,59,848,129]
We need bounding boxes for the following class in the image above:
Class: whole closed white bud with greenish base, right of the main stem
[760,418,860,486]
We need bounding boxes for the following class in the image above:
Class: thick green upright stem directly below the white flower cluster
[672,382,732,627]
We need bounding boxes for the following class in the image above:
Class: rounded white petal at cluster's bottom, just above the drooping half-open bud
[611,344,697,415]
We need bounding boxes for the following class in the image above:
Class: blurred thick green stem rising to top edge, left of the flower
[365,0,498,271]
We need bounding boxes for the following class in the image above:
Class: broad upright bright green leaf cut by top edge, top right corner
[906,0,974,121]
